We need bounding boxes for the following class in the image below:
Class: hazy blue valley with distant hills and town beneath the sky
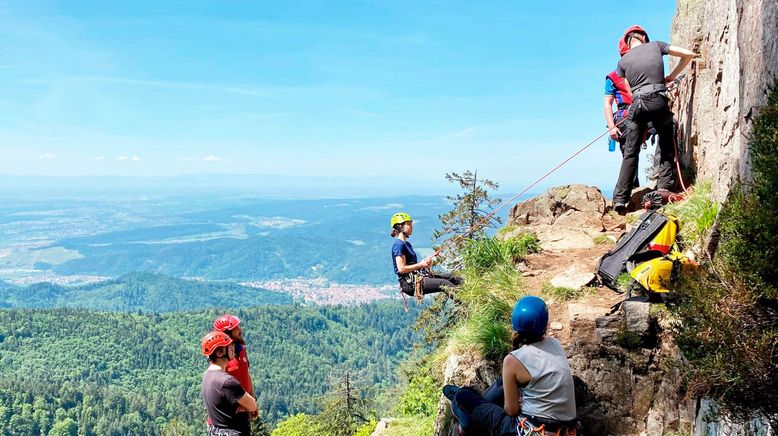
[0,195,450,285]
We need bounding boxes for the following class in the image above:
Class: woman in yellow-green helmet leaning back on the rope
[390,212,462,295]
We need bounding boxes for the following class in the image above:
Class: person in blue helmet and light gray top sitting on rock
[443,296,577,436]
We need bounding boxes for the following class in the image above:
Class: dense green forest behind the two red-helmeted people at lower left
[0,301,416,435]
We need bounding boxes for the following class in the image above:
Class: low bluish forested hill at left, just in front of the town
[0,273,292,312]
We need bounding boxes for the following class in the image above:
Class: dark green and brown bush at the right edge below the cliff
[673,81,778,417]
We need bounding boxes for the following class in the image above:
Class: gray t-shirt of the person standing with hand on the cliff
[616,41,670,93]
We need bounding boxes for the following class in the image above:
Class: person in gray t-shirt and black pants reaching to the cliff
[613,26,696,215]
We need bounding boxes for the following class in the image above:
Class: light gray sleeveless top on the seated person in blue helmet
[511,337,576,421]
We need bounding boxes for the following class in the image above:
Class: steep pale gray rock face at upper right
[671,0,778,200]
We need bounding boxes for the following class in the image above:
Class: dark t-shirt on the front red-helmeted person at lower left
[203,370,251,435]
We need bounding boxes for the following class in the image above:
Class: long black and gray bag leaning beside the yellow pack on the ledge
[597,210,668,291]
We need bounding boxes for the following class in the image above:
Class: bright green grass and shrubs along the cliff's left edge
[394,233,540,435]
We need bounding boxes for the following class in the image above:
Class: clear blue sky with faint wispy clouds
[0,0,675,190]
